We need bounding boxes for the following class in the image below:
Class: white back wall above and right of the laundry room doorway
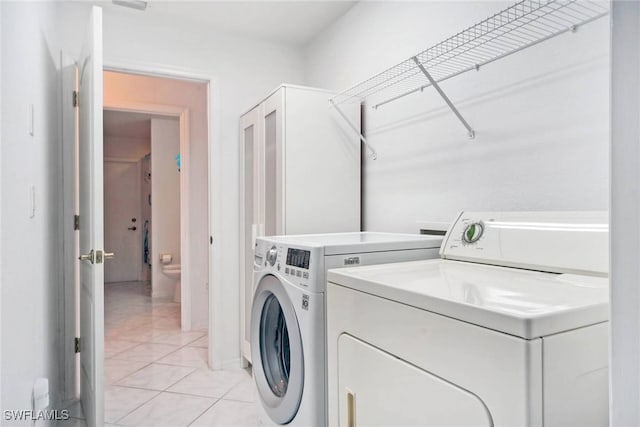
[53,2,304,367]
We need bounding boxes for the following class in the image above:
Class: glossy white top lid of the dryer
[328,260,609,339]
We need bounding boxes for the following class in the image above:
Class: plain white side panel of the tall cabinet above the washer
[284,87,360,234]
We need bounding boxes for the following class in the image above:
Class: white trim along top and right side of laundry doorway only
[104,58,224,369]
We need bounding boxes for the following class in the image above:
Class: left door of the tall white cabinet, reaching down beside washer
[240,107,264,362]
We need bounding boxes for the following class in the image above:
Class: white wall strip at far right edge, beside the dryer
[610,1,640,427]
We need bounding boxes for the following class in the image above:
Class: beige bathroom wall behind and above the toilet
[151,119,180,298]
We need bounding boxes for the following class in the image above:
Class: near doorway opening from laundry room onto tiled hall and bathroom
[103,71,209,423]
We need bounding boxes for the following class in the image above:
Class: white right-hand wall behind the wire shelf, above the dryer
[306,2,609,232]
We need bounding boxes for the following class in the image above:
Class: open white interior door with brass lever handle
[78,6,104,426]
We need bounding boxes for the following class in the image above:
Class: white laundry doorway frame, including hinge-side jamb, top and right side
[60,59,222,402]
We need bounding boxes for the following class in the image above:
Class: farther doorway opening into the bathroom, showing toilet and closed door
[103,110,182,302]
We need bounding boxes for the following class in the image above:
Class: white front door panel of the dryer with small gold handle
[338,334,493,427]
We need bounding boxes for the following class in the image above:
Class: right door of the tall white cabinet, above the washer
[262,88,286,236]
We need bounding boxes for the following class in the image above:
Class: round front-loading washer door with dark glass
[251,274,304,424]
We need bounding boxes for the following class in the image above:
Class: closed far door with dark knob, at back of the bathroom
[104,159,142,283]
